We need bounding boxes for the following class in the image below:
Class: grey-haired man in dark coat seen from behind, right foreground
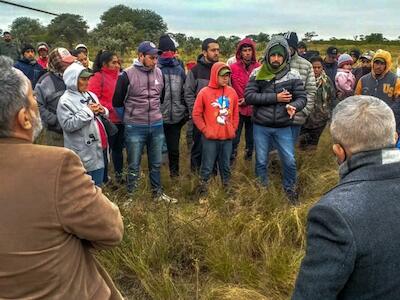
[292,96,400,300]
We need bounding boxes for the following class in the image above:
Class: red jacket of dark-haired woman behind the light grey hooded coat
[88,67,121,123]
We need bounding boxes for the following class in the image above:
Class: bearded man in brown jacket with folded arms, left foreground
[0,56,123,300]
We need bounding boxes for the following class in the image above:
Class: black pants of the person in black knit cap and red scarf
[164,119,186,177]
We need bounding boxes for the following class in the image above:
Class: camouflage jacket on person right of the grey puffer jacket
[303,72,335,129]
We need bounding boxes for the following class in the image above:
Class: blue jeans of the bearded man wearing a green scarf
[253,124,296,191]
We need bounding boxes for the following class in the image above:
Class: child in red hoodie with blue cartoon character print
[192,62,239,195]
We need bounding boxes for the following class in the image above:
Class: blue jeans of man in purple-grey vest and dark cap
[125,123,164,194]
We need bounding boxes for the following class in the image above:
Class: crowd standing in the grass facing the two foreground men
[3,32,400,203]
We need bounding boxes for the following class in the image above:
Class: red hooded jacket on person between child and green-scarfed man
[231,38,260,116]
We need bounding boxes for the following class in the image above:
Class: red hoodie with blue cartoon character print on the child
[192,62,239,140]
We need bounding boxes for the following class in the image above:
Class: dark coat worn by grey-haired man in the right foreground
[292,148,400,300]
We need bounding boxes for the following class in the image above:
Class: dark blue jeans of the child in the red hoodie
[200,136,232,185]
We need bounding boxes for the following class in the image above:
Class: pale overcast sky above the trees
[0,0,400,39]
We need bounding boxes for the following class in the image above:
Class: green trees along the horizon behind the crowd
[3,5,400,56]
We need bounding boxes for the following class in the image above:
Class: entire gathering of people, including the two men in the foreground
[0,27,400,299]
